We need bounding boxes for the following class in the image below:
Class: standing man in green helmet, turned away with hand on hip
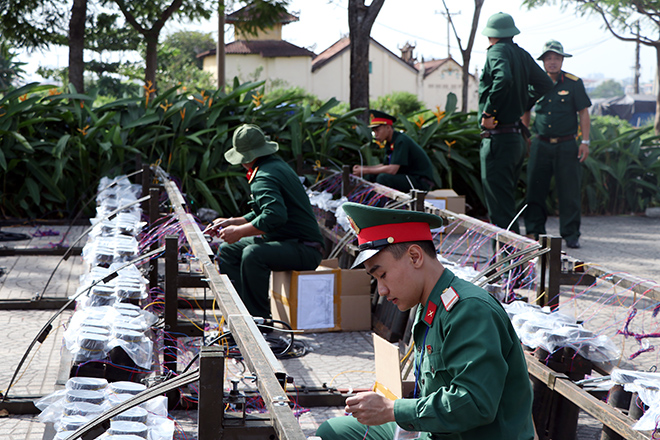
[479,12,552,233]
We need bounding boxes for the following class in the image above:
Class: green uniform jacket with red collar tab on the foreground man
[394,269,534,440]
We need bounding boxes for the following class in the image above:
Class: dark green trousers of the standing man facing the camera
[525,138,582,241]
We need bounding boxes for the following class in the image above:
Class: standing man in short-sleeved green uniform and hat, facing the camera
[525,40,591,249]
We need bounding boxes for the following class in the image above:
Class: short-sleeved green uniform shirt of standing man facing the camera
[534,71,591,137]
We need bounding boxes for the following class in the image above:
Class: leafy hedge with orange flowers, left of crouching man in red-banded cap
[0,81,369,218]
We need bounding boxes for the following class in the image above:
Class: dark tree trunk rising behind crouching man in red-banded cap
[348,0,385,122]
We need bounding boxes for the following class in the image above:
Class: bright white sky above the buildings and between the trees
[18,0,656,83]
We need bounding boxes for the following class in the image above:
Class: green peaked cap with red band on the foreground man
[341,202,442,269]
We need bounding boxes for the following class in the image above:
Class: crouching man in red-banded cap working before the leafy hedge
[353,110,434,192]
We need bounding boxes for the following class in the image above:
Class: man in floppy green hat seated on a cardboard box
[205,124,323,318]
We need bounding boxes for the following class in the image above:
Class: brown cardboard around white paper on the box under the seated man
[270,260,371,332]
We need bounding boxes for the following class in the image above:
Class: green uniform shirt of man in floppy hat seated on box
[244,154,323,244]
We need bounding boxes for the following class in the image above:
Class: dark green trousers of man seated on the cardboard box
[219,237,322,318]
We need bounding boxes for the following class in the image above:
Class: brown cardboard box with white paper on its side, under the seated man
[270,260,371,332]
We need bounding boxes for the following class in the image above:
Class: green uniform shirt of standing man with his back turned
[479,38,552,125]
